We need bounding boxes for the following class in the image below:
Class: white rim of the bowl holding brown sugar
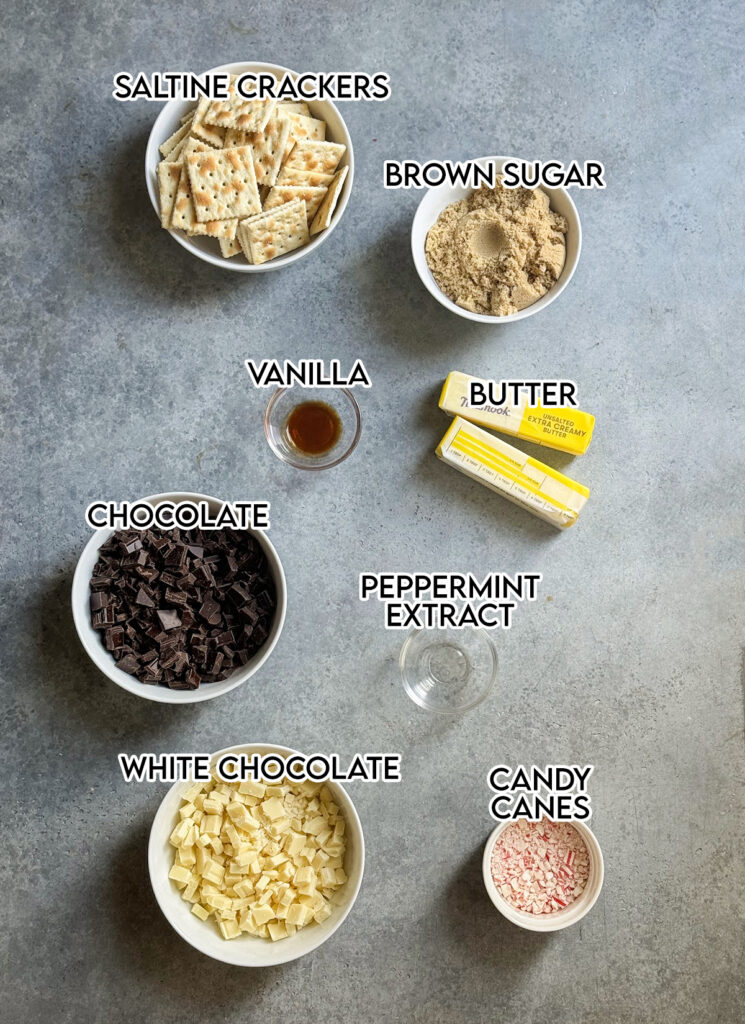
[411,157,582,325]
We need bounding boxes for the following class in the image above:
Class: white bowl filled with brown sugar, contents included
[411,157,582,324]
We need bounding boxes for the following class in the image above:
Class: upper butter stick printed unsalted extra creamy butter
[440,371,595,455]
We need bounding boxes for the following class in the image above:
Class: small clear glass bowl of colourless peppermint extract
[398,628,498,715]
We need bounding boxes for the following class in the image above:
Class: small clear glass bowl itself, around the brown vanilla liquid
[264,387,362,469]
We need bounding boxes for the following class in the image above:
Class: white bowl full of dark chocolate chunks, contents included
[73,494,287,703]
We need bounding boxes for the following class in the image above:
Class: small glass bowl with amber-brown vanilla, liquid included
[264,387,362,469]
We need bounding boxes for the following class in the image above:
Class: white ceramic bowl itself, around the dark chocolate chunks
[73,494,288,703]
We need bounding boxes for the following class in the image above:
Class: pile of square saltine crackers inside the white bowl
[158,78,349,263]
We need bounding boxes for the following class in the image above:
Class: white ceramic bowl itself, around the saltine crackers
[145,61,354,273]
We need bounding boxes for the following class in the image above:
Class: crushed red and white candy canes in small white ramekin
[491,818,589,913]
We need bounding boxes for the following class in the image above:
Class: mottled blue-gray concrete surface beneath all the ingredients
[0,0,745,1024]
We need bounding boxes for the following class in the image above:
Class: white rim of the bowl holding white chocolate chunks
[147,742,365,968]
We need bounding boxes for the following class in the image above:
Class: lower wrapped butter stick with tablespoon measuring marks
[436,416,589,529]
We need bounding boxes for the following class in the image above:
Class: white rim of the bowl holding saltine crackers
[144,60,354,273]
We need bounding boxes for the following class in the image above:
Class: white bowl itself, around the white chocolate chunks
[147,743,364,967]
